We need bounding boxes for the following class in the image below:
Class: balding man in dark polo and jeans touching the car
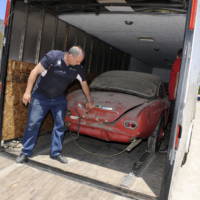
[16,46,92,163]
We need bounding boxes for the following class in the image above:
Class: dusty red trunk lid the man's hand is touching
[68,90,148,122]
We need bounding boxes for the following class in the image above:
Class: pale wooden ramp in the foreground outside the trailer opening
[0,153,136,200]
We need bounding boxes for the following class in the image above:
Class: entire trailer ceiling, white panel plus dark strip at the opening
[25,0,188,68]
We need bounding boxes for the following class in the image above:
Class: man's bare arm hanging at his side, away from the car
[22,63,45,105]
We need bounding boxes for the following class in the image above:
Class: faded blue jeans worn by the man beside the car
[22,94,67,157]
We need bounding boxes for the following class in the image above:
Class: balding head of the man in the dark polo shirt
[64,46,85,65]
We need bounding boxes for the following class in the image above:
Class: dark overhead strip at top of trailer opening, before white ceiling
[24,0,188,15]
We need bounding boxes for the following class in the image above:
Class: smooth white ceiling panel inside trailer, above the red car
[59,14,186,67]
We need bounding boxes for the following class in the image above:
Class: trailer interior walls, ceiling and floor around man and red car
[2,0,190,199]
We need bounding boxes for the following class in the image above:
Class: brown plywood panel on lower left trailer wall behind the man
[2,60,53,140]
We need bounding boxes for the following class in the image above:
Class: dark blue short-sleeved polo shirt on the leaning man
[34,50,85,98]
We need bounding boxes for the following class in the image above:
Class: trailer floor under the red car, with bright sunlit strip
[2,133,166,199]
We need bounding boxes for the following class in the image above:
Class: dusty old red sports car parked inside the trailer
[65,71,169,148]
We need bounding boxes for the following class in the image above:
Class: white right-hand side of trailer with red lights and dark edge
[160,0,200,200]
